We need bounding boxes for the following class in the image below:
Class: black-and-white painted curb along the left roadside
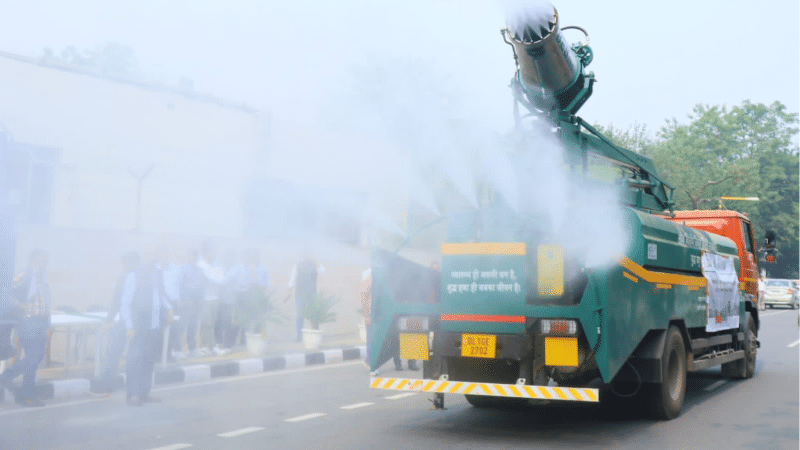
[0,346,367,403]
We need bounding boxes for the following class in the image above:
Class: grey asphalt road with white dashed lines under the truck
[0,310,800,450]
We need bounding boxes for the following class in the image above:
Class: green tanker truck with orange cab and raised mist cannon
[368,3,759,419]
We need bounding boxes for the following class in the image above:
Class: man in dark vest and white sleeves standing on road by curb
[119,250,174,406]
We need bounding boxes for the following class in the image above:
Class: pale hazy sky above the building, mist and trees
[0,0,800,136]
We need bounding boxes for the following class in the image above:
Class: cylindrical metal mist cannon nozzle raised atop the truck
[502,2,595,114]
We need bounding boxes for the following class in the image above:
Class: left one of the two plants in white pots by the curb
[234,287,281,356]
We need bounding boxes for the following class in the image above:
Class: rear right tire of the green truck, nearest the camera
[648,325,686,420]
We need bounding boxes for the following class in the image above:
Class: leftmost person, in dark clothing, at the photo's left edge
[0,249,50,406]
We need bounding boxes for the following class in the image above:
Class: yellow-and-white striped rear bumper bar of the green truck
[370,377,600,402]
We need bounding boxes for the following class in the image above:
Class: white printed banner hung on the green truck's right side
[701,252,739,331]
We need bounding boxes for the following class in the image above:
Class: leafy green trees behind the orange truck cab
[603,101,800,278]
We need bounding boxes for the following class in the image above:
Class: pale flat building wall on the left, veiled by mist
[0,55,267,236]
